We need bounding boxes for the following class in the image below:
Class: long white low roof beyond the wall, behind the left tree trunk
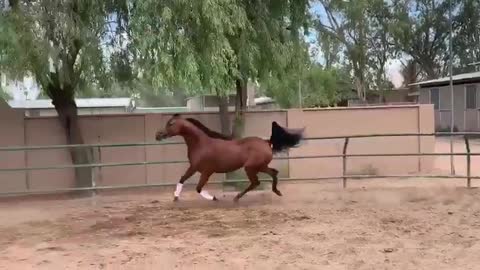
[8,98,132,109]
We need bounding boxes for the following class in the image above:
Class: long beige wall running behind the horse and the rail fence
[0,105,434,192]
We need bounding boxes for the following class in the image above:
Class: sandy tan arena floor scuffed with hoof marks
[0,179,480,270]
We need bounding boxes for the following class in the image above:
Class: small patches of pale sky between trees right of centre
[306,2,403,87]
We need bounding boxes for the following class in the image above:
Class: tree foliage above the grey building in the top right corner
[391,0,480,79]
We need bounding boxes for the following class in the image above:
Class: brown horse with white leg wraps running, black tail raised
[156,114,303,201]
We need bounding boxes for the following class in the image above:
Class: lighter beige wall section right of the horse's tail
[288,105,434,178]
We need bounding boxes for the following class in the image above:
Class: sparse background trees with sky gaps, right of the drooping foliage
[315,0,480,98]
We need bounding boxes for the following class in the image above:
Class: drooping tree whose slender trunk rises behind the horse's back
[229,0,309,137]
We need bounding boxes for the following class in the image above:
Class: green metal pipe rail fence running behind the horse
[0,132,480,196]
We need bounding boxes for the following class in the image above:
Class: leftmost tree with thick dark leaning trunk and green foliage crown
[0,0,126,187]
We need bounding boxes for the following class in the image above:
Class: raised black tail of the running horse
[270,121,303,152]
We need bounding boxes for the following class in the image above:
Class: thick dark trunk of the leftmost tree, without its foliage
[49,88,92,190]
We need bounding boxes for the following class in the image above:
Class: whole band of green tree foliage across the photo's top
[0,0,480,112]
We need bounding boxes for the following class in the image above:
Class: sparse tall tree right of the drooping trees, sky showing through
[316,0,399,100]
